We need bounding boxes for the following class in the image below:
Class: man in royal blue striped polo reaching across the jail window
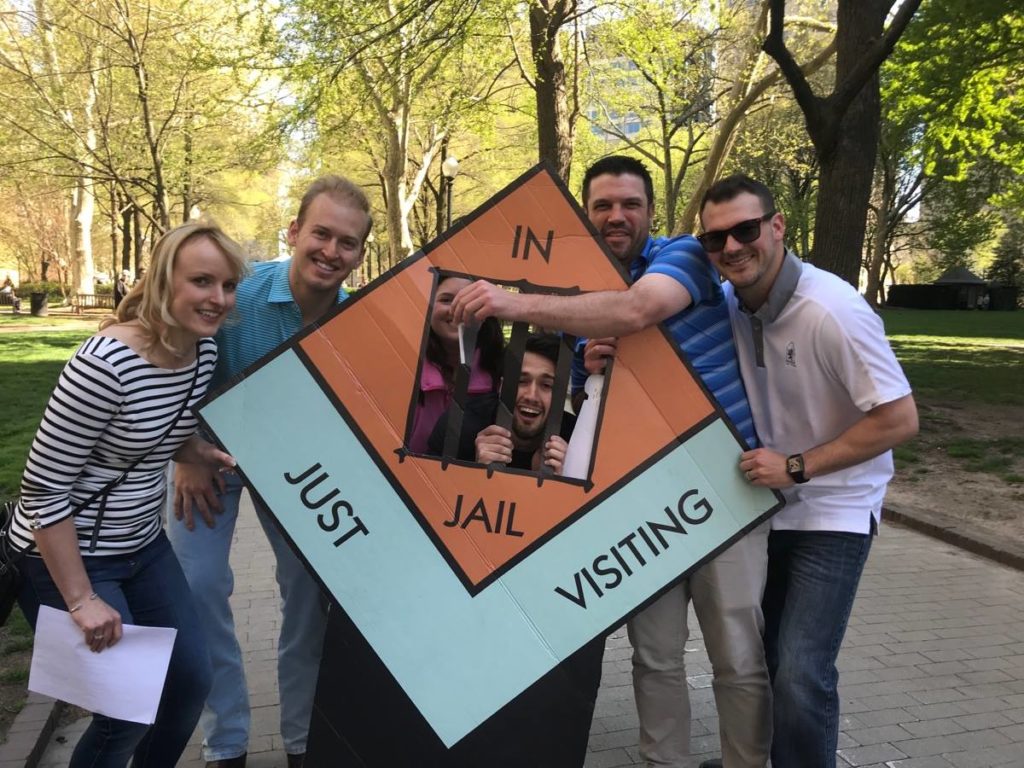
[453,156,771,768]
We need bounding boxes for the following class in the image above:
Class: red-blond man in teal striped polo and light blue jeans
[168,176,372,768]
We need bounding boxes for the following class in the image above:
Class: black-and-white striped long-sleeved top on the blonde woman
[11,336,217,555]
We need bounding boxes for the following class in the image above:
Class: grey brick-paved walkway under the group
[41,495,1024,768]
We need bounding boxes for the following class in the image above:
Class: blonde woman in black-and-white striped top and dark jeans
[11,222,246,768]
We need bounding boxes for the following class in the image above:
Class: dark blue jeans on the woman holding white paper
[18,532,210,768]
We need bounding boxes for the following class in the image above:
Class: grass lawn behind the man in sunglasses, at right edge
[882,309,1024,406]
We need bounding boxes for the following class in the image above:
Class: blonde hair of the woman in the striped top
[99,219,249,354]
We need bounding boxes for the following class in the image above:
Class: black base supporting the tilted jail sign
[305,605,604,768]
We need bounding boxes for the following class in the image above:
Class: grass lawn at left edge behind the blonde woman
[0,321,95,499]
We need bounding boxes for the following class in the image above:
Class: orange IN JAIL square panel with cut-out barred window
[300,167,714,585]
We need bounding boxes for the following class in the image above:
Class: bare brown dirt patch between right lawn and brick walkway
[886,399,1024,543]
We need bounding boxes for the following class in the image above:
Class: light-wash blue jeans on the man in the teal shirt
[167,474,327,761]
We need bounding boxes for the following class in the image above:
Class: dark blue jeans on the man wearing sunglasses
[764,530,871,768]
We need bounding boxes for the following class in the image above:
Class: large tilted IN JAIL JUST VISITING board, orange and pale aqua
[195,166,779,746]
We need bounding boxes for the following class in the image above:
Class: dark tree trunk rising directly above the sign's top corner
[529,0,577,183]
